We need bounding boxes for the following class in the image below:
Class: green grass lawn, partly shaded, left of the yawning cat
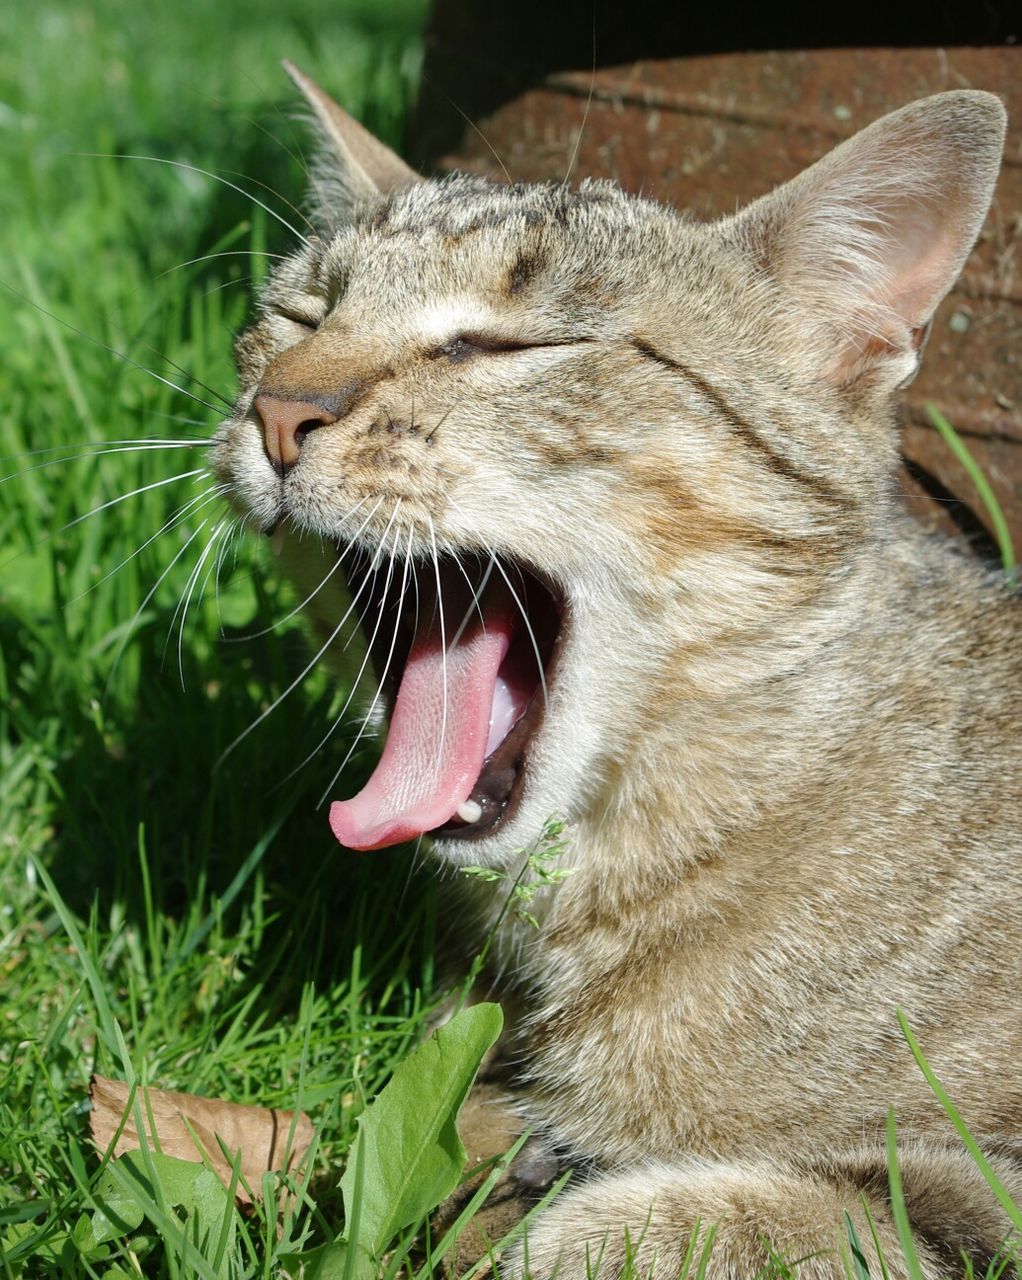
[0,0,1022,1280]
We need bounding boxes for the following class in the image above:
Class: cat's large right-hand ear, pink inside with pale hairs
[730,90,1005,390]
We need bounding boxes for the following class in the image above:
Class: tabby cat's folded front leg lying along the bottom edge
[501,1153,1009,1280]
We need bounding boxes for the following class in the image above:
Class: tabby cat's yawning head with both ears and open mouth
[214,69,1004,865]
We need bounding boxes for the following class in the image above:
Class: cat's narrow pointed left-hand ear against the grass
[283,60,423,225]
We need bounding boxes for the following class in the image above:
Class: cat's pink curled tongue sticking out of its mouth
[330,586,514,849]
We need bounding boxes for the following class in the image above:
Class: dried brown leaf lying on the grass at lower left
[88,1075,312,1204]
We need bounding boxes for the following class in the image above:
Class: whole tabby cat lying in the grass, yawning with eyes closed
[216,77,1022,1277]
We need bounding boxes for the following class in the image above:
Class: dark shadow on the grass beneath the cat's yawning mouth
[12,576,432,1034]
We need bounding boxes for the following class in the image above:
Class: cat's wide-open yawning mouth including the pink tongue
[330,542,566,850]
